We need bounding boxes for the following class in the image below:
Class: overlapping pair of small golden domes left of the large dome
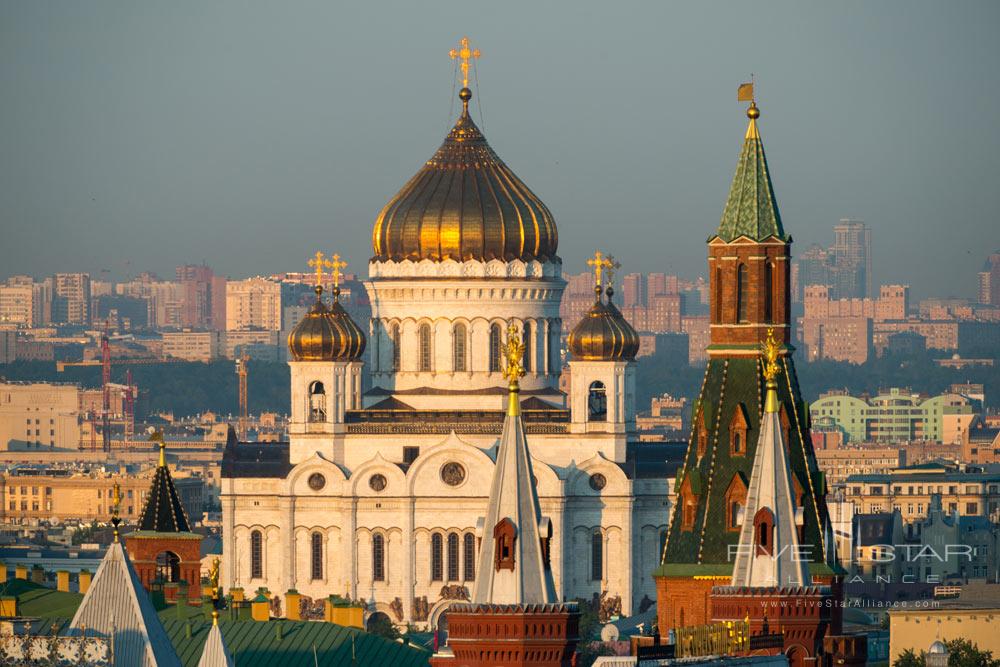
[288,287,365,361]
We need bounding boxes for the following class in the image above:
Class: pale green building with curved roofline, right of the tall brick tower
[809,388,976,442]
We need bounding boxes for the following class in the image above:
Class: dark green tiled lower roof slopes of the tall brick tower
[663,358,826,574]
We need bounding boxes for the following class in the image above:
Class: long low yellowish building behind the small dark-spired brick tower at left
[0,465,205,524]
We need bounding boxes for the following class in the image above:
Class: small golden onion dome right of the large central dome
[569,287,639,361]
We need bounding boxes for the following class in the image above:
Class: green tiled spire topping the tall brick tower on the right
[717,104,787,243]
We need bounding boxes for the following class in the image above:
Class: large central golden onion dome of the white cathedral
[372,88,559,262]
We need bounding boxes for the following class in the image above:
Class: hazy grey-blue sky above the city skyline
[0,0,1000,296]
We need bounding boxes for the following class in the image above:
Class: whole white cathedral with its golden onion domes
[222,64,670,627]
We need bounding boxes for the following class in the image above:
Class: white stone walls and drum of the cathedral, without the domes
[222,262,671,626]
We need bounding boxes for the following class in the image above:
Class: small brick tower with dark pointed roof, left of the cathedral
[125,440,202,601]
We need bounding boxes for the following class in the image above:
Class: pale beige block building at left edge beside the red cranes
[0,382,80,451]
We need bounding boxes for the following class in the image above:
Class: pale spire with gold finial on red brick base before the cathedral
[431,325,580,667]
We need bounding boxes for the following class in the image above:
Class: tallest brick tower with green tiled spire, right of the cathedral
[654,92,838,634]
